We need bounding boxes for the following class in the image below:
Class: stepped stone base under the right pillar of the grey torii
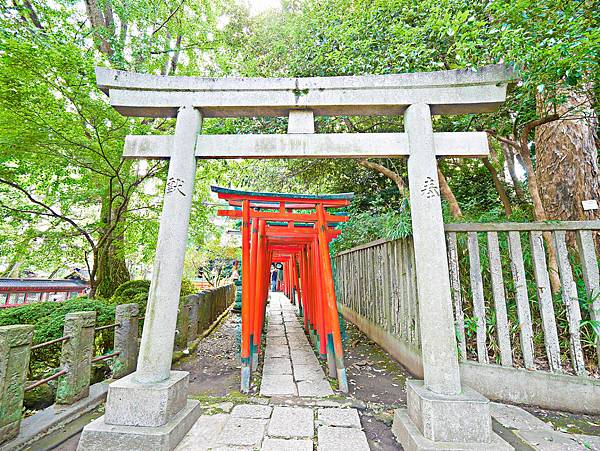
[392,381,513,451]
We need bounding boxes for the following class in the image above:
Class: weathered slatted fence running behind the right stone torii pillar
[335,221,600,376]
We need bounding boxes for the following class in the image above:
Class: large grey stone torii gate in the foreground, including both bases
[79,65,515,451]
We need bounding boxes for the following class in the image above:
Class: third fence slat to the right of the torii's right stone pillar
[487,232,512,366]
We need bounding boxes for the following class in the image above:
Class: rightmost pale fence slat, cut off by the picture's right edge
[577,230,600,365]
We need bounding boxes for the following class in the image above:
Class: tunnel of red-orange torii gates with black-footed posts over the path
[212,186,353,392]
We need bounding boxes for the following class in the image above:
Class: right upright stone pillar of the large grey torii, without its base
[404,104,461,395]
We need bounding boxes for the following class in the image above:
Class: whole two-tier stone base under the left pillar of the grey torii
[77,371,201,451]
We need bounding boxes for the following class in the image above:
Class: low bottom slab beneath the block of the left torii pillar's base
[77,400,202,451]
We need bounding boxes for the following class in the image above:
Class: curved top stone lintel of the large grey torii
[96,65,515,117]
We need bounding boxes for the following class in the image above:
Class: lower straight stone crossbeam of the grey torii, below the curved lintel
[123,132,489,159]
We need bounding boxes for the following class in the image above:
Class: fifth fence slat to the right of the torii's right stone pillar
[529,231,561,372]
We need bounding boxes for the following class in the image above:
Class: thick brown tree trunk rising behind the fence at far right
[535,93,600,221]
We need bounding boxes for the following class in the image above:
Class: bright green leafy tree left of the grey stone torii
[0,0,234,297]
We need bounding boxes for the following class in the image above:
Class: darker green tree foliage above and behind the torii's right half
[213,0,600,249]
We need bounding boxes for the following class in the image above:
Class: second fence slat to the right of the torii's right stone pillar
[467,232,489,363]
